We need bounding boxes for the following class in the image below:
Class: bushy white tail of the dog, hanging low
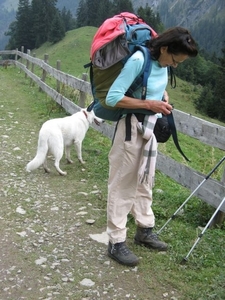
[26,135,48,172]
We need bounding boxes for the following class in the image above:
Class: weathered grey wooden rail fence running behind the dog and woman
[0,47,225,224]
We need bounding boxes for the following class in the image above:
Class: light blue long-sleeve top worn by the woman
[106,50,168,107]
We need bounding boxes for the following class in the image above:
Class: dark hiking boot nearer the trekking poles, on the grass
[134,227,168,251]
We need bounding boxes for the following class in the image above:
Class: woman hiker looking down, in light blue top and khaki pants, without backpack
[96,27,198,266]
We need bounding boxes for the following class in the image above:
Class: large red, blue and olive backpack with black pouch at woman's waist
[85,12,188,160]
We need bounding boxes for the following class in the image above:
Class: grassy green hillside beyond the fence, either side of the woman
[32,27,224,125]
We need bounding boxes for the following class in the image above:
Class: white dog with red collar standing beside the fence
[26,109,103,175]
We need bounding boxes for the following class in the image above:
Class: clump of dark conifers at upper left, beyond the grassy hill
[5,0,69,50]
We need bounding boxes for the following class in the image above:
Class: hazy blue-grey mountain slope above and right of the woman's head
[132,0,225,54]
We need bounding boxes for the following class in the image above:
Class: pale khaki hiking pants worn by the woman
[107,115,155,244]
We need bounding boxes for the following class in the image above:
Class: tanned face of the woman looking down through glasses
[158,47,188,68]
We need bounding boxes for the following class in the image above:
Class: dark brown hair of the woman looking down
[147,27,198,60]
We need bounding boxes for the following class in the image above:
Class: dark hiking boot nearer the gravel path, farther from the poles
[108,242,139,267]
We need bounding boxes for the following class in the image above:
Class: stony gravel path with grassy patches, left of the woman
[0,71,178,300]
